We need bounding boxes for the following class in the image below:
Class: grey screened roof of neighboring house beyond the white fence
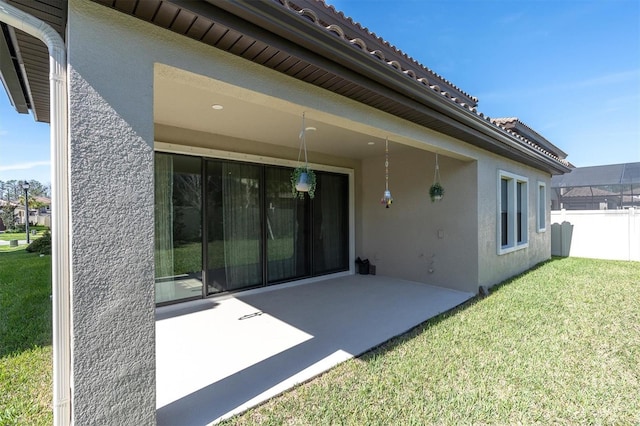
[551,163,640,188]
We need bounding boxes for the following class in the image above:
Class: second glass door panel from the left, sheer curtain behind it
[206,161,263,294]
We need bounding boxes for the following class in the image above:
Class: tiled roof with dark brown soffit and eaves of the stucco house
[0,0,571,174]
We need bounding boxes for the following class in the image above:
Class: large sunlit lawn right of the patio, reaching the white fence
[223,258,640,425]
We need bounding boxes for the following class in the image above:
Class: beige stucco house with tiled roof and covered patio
[0,0,570,424]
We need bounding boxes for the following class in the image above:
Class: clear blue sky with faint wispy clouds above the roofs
[0,0,640,184]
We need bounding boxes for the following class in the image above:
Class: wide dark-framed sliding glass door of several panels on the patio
[155,153,349,303]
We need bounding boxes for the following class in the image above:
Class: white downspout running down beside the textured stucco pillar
[0,0,71,425]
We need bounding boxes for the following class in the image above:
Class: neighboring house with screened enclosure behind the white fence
[551,163,640,210]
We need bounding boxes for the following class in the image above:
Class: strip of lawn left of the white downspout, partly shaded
[0,246,53,426]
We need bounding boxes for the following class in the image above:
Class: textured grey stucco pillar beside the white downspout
[67,0,155,425]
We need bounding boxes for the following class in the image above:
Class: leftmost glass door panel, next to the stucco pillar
[154,153,202,303]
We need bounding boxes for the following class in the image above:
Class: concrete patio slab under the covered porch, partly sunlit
[156,275,474,425]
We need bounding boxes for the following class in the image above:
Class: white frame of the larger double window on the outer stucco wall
[496,170,529,255]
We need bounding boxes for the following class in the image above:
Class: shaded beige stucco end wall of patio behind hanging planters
[359,146,478,293]
